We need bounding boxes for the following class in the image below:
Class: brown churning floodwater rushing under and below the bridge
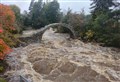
[5,29,120,82]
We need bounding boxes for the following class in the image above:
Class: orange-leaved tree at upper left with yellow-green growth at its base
[0,4,18,47]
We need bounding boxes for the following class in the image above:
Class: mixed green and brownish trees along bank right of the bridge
[59,0,120,48]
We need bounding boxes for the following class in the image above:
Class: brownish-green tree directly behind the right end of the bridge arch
[60,9,85,37]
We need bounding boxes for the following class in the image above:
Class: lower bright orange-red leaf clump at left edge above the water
[0,39,12,59]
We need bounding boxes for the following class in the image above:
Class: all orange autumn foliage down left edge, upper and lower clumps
[0,4,15,59]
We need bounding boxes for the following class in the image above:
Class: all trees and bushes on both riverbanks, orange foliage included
[0,0,120,82]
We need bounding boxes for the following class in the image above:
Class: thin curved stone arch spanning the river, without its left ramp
[39,23,75,41]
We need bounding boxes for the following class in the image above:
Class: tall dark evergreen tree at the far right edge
[89,0,120,47]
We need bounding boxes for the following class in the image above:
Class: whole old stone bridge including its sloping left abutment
[20,23,75,43]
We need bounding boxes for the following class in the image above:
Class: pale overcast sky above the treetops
[0,0,91,14]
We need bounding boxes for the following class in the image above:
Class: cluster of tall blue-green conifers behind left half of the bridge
[24,0,60,29]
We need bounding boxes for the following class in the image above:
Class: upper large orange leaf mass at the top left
[0,4,15,30]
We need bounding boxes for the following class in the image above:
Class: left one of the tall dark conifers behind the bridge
[29,0,45,28]
